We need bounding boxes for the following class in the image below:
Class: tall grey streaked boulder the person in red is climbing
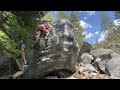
[24,20,78,78]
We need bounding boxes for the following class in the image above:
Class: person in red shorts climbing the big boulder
[35,22,49,43]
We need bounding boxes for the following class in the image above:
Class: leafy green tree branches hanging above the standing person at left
[0,11,46,56]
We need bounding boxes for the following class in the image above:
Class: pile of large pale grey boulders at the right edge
[80,48,120,79]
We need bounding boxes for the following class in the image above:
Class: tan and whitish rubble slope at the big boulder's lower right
[72,63,111,79]
